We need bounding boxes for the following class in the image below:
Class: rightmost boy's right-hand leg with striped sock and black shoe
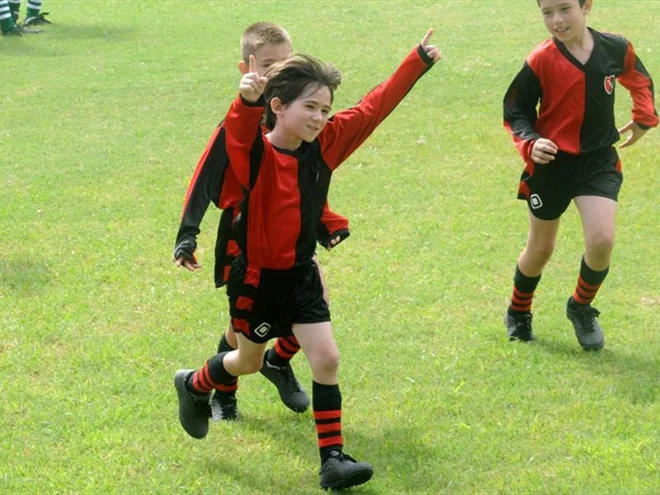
[566,196,617,350]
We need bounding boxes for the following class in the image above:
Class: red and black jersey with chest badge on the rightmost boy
[504,28,658,162]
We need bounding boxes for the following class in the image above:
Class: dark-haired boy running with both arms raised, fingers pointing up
[174,31,440,489]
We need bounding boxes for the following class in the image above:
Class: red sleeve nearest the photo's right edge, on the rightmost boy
[617,42,658,129]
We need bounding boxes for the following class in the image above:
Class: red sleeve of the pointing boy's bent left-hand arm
[224,95,264,189]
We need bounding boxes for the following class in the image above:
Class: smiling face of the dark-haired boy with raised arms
[271,85,332,147]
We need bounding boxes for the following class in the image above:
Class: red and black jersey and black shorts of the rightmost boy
[504,28,658,220]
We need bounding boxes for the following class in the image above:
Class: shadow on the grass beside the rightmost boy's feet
[536,336,660,404]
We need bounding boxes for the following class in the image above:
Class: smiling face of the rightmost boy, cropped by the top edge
[539,0,592,43]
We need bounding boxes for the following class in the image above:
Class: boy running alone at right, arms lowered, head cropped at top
[504,0,658,350]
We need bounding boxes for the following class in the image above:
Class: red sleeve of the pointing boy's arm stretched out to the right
[319,46,433,170]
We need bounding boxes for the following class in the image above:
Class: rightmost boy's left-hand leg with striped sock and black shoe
[504,213,559,341]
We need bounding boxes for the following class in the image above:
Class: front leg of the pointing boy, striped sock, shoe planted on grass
[293,322,373,489]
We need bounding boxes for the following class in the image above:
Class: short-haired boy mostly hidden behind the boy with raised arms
[174,22,349,419]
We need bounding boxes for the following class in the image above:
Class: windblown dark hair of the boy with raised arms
[264,54,341,129]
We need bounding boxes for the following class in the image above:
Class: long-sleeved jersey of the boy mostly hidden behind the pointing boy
[174,115,350,287]
